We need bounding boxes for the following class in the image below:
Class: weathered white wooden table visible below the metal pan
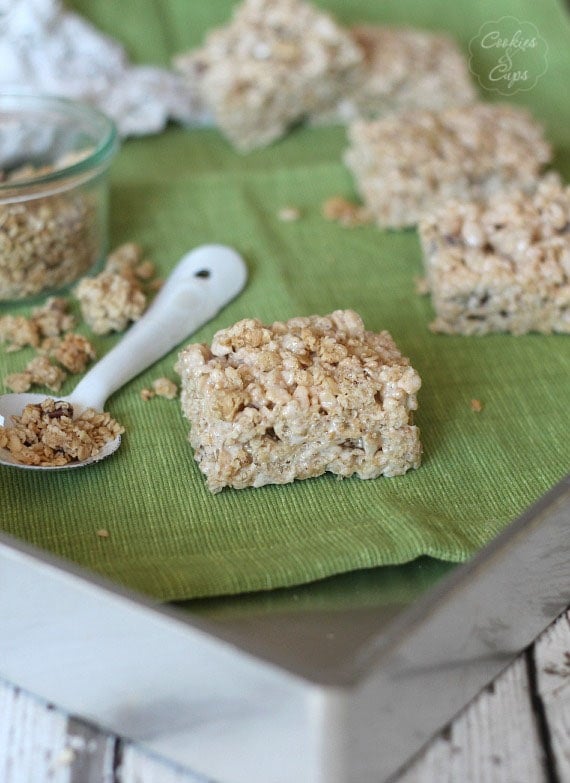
[0,610,570,783]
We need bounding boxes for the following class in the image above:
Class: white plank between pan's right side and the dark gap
[397,656,548,783]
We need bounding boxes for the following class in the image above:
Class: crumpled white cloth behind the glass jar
[0,0,211,137]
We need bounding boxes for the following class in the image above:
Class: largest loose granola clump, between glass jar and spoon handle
[75,271,147,334]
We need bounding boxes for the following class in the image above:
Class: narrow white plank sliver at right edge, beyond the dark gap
[533,610,570,781]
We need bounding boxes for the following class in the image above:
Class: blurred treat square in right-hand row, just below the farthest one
[344,103,552,228]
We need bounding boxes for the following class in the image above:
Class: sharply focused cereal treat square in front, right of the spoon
[176,310,421,492]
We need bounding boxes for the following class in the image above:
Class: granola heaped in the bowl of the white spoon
[0,397,124,467]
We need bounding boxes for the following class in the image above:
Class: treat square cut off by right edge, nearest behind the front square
[419,176,570,334]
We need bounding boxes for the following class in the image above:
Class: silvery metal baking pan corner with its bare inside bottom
[0,479,570,783]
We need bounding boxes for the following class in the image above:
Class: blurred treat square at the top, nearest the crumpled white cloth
[174,0,362,152]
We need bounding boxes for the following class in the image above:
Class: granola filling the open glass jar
[0,152,101,301]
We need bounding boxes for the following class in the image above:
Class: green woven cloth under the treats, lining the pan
[0,0,570,600]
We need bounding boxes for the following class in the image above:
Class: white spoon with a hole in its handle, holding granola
[0,245,247,470]
